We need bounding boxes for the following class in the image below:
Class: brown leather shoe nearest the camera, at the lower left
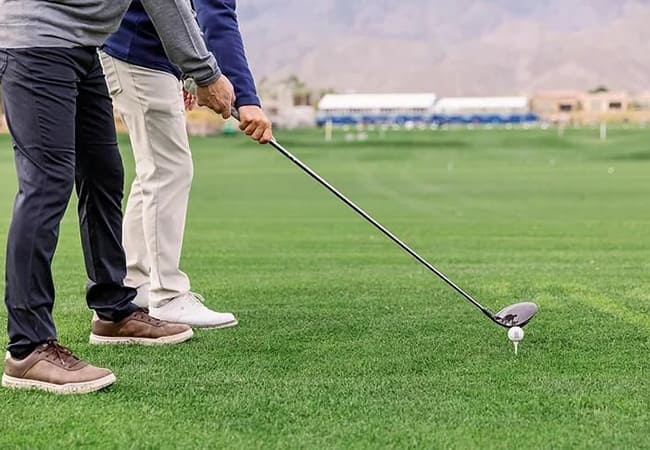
[2,341,115,394]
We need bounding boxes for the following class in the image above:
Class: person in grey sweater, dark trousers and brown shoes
[0,0,234,393]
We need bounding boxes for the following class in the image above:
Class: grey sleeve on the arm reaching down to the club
[141,0,221,86]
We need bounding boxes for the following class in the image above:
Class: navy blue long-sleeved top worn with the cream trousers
[103,0,260,108]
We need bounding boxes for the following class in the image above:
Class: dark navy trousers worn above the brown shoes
[0,48,136,358]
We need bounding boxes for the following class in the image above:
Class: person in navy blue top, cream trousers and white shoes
[101,0,272,328]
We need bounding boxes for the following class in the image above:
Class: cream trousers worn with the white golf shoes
[97,54,193,306]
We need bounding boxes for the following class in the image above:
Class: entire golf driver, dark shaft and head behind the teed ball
[231,104,539,328]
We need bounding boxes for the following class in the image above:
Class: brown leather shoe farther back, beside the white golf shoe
[90,309,194,345]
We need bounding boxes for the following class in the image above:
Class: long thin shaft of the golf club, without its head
[225,108,495,321]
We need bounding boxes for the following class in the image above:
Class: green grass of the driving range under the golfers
[0,129,650,449]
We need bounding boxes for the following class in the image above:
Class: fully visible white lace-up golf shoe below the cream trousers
[149,292,238,328]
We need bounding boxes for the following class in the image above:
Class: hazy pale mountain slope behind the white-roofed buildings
[239,0,650,95]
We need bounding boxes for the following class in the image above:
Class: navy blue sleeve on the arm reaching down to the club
[194,0,260,107]
